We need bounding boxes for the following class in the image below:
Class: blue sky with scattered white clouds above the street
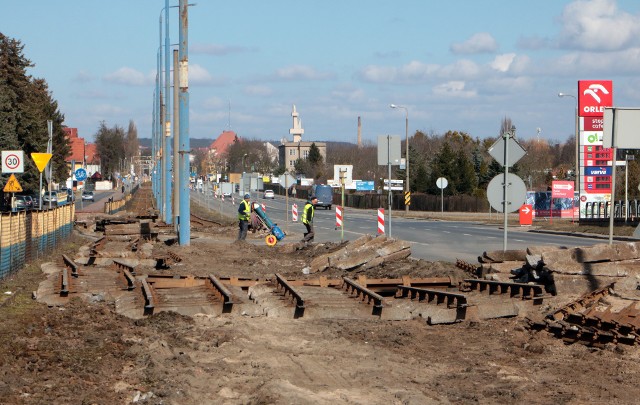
[0,0,640,142]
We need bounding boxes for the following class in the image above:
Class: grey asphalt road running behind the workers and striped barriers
[192,192,607,263]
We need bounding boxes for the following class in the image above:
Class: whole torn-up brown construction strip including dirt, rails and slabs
[0,188,640,405]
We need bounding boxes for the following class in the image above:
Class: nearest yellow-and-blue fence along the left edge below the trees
[0,204,75,279]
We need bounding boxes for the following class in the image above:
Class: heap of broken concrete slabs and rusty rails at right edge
[458,242,640,346]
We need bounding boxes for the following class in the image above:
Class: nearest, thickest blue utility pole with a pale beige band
[178,0,191,246]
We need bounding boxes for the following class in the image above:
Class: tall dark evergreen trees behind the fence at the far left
[0,32,70,191]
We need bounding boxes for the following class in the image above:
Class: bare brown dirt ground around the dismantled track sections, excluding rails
[0,207,640,405]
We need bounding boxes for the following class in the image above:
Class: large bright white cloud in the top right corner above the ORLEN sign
[560,0,640,51]
